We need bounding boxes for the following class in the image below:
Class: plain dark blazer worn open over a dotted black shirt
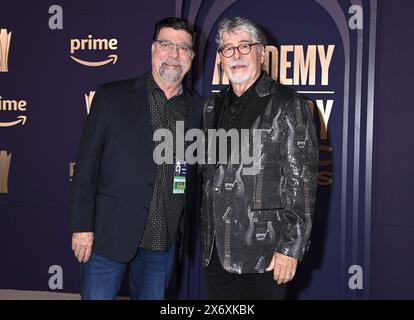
[70,75,203,262]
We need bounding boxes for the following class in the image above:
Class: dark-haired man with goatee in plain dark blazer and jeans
[70,18,202,299]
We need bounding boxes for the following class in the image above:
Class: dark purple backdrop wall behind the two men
[0,0,414,299]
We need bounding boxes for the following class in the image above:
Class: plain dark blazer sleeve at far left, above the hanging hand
[69,86,107,232]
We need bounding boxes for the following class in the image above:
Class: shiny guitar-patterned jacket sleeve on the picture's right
[276,95,319,260]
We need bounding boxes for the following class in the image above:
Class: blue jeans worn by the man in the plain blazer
[81,241,176,300]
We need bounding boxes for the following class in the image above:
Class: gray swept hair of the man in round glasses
[216,17,267,49]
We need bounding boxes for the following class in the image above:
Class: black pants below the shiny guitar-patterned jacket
[205,246,286,300]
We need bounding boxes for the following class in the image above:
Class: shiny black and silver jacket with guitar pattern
[201,73,318,273]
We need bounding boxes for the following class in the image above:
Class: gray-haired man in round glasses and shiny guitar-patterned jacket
[201,17,318,299]
